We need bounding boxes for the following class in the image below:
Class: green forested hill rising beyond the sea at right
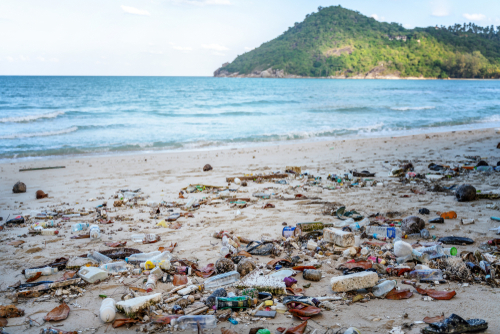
[214,6,500,79]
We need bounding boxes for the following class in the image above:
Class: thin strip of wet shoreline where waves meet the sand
[0,123,497,165]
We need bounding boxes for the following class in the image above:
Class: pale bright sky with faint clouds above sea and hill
[0,0,500,76]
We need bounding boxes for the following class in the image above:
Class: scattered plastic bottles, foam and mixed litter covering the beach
[0,157,500,334]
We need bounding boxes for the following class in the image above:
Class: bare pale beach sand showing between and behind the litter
[0,129,500,334]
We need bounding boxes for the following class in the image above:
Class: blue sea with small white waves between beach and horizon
[0,76,500,160]
